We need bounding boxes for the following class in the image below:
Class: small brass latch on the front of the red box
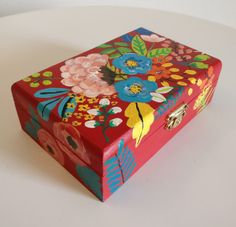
[166,103,188,130]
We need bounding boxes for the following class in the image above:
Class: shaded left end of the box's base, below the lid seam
[11,96,103,201]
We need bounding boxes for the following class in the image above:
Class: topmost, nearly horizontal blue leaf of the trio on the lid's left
[34,87,69,99]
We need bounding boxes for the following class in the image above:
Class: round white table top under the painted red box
[0,7,236,227]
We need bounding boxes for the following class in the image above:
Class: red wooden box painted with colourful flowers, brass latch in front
[12,28,221,201]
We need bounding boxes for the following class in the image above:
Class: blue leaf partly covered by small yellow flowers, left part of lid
[58,96,77,118]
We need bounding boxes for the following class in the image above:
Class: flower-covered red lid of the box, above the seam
[12,28,221,175]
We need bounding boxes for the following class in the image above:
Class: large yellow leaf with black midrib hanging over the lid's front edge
[125,102,154,147]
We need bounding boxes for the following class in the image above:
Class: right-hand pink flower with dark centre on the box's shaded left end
[53,122,91,164]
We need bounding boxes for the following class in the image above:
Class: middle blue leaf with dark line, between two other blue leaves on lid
[37,98,62,121]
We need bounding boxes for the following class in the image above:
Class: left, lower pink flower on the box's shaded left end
[38,128,65,165]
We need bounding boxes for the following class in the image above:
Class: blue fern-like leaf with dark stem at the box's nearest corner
[105,139,136,193]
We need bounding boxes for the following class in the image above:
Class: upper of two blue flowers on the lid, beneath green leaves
[113,53,152,75]
